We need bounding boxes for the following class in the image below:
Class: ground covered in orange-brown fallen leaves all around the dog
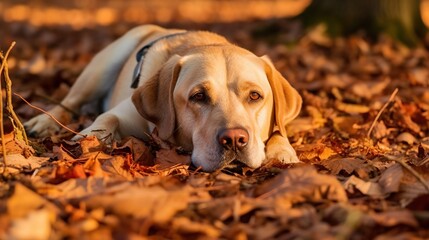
[0,21,429,239]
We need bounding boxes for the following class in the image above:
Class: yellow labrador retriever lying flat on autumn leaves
[25,25,302,171]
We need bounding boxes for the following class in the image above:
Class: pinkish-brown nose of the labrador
[218,128,249,151]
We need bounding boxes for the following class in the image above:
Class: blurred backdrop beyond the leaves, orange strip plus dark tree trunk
[0,0,429,45]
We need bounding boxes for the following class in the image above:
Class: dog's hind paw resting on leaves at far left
[24,108,71,137]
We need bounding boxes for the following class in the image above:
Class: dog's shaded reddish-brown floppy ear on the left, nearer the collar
[132,55,181,140]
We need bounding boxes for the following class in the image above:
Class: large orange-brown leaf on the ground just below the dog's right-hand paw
[255,167,347,205]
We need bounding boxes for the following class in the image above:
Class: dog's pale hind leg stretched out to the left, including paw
[24,25,162,136]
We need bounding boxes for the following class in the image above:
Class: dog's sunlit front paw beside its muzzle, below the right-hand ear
[266,134,300,163]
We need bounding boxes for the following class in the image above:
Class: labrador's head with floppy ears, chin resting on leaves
[132,45,301,171]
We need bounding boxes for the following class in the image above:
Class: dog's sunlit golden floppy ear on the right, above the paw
[261,56,302,137]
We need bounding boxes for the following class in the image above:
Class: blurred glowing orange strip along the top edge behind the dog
[0,0,311,29]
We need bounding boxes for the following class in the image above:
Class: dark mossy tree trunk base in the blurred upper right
[298,0,426,45]
